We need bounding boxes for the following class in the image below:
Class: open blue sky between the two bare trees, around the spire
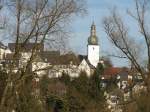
[69,0,135,67]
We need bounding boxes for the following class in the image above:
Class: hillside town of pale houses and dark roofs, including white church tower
[0,23,146,112]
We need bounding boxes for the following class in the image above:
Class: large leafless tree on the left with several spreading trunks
[0,0,85,111]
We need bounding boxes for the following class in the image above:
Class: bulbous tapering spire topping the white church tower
[88,22,98,45]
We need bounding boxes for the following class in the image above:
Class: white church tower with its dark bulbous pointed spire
[87,22,100,67]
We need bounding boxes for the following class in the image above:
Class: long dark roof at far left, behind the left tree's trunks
[8,43,44,52]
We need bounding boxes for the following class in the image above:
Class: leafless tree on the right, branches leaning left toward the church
[103,0,150,91]
